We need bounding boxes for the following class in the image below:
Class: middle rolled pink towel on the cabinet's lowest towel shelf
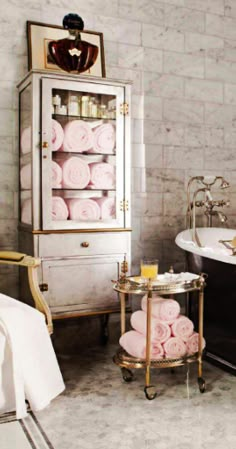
[67,198,100,221]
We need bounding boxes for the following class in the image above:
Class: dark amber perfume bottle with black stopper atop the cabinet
[48,14,98,73]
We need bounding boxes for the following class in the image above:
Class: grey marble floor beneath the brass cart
[31,314,236,449]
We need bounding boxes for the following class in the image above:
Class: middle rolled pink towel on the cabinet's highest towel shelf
[61,120,93,153]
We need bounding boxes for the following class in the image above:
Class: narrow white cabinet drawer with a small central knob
[38,232,130,258]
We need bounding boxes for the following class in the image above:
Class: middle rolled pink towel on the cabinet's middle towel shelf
[60,156,90,189]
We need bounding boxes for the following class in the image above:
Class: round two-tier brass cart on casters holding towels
[113,274,205,400]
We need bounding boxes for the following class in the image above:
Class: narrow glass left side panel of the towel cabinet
[19,83,32,225]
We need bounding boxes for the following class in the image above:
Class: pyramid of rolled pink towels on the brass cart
[120,295,206,360]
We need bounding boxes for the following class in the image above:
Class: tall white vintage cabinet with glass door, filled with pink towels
[18,71,131,328]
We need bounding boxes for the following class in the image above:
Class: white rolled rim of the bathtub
[175,227,236,265]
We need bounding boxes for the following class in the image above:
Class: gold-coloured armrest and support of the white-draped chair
[0,251,53,334]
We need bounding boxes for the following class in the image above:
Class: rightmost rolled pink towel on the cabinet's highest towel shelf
[90,123,116,154]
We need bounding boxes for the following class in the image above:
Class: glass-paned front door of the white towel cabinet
[41,79,125,229]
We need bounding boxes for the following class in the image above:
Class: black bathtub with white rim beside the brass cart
[175,228,236,375]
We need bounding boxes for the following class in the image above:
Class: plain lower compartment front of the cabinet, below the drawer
[42,256,122,314]
